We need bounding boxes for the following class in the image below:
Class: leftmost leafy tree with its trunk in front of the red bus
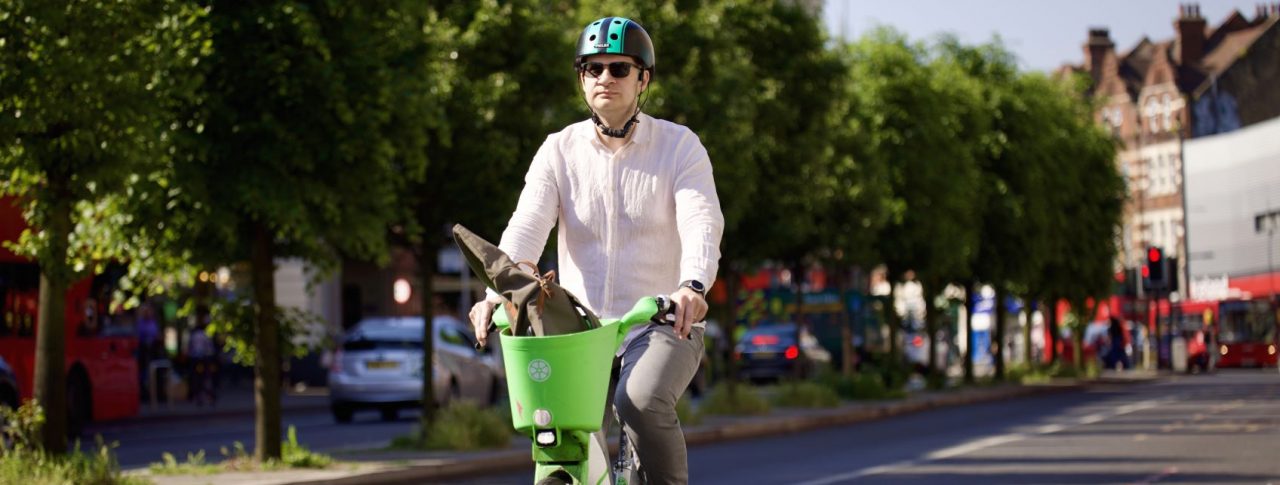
[0,0,206,453]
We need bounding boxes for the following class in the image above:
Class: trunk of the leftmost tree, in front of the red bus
[35,193,72,456]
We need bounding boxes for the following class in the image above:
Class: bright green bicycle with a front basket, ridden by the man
[489,296,675,485]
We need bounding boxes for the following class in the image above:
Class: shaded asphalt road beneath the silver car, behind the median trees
[90,409,419,470]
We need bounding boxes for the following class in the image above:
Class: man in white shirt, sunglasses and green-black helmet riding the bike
[470,17,724,484]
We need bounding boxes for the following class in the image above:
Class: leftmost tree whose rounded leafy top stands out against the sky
[847,29,978,368]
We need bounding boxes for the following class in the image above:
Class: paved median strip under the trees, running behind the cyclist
[129,371,1160,485]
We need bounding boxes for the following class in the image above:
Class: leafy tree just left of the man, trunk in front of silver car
[393,0,582,424]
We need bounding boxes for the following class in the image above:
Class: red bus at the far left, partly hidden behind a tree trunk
[0,197,141,434]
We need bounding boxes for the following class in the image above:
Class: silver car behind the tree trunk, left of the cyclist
[329,317,506,422]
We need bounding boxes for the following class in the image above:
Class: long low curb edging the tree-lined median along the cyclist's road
[285,380,1121,485]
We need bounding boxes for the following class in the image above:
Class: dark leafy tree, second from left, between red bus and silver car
[126,0,443,459]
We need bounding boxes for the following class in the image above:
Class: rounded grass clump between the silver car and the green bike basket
[390,402,512,450]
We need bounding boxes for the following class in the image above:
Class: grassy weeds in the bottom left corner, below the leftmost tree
[0,401,150,485]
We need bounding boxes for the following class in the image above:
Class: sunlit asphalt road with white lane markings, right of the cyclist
[454,369,1280,485]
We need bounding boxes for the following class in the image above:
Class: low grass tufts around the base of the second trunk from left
[148,426,333,475]
